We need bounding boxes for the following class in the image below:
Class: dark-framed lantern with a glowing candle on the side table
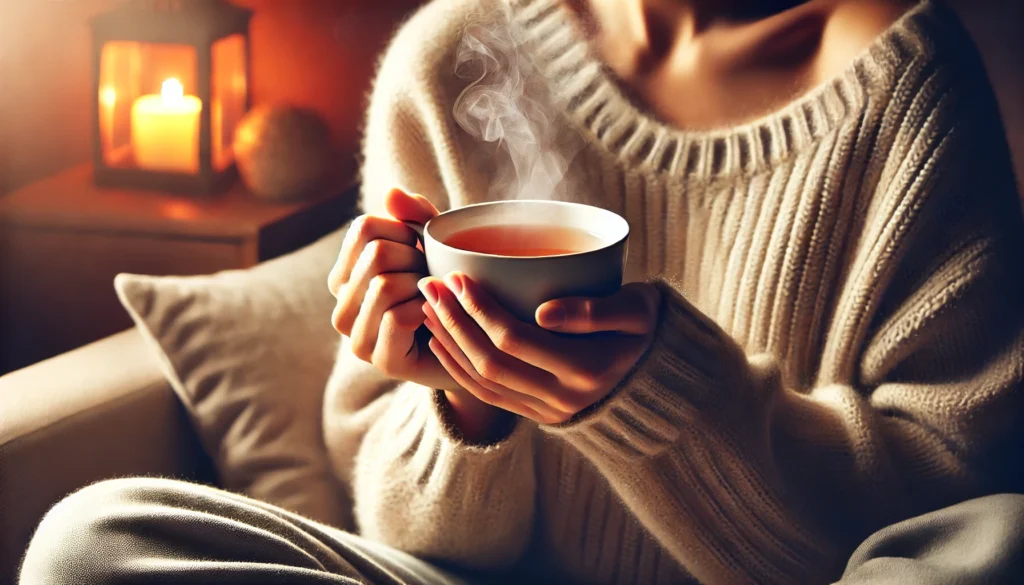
[91,0,252,194]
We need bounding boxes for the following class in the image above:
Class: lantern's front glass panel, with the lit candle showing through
[98,41,202,173]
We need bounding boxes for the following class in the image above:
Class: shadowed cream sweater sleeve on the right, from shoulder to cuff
[546,78,1024,584]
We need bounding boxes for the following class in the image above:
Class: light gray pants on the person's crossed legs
[20,478,1024,585]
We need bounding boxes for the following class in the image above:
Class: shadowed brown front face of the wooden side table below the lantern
[0,226,245,373]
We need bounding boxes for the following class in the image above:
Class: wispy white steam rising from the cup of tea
[453,12,582,199]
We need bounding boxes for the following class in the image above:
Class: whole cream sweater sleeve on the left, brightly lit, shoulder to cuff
[324,2,537,569]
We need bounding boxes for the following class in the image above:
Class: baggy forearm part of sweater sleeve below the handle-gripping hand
[353,377,536,570]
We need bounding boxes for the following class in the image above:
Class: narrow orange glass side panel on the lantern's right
[210,35,248,171]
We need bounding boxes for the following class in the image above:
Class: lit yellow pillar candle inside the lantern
[131,78,203,174]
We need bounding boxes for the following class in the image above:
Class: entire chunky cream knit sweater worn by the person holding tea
[324,0,1024,584]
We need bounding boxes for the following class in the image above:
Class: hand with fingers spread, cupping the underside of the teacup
[419,273,660,424]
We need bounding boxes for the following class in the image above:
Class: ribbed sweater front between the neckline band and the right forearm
[567,139,870,384]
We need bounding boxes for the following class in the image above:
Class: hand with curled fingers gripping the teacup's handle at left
[328,189,457,388]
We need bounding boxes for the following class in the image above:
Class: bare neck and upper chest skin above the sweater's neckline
[591,0,909,130]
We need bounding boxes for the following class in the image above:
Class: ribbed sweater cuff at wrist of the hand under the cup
[544,282,754,459]
